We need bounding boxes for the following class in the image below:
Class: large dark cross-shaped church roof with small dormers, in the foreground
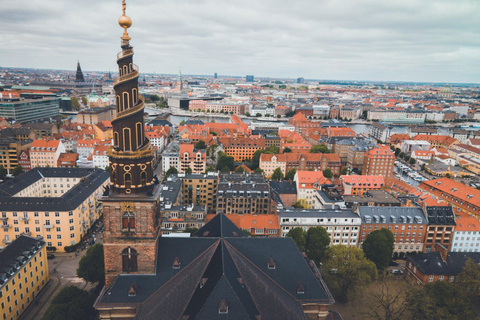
[96,214,334,320]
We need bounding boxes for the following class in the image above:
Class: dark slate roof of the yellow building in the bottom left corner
[0,235,45,285]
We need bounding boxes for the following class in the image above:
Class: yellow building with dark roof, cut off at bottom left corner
[0,235,49,320]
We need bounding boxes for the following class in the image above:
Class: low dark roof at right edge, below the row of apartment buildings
[407,251,480,276]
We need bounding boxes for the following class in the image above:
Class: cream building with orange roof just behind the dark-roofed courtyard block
[30,140,66,168]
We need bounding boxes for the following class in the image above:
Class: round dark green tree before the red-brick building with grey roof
[362,229,395,272]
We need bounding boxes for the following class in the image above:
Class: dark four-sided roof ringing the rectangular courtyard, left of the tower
[0,168,110,211]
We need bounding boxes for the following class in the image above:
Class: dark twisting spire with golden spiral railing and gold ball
[108,3,153,194]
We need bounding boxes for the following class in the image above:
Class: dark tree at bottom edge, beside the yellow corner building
[42,286,96,320]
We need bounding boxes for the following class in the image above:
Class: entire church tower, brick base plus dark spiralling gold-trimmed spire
[102,0,161,287]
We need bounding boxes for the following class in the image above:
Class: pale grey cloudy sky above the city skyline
[0,0,480,83]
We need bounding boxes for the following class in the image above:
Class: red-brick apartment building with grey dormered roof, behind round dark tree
[358,206,428,253]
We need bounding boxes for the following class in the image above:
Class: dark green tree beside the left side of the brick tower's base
[77,243,105,284]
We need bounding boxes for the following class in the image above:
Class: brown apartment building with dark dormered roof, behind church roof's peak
[216,173,275,214]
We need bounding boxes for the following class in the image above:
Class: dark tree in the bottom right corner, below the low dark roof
[407,281,475,320]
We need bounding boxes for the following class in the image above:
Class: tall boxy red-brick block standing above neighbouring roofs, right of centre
[362,146,395,180]
